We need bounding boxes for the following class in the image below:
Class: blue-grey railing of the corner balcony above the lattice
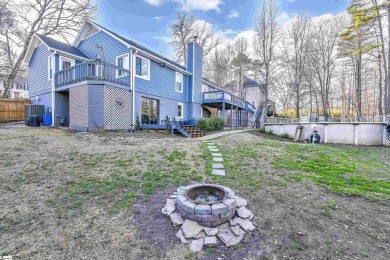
[54,61,130,88]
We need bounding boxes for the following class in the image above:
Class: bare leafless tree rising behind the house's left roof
[0,0,96,97]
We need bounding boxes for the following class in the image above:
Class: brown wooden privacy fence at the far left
[0,98,30,123]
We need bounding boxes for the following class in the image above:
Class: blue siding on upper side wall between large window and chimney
[135,57,188,102]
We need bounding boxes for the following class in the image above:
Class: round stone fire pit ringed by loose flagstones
[162,184,255,252]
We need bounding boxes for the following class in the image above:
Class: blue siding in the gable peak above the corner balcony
[77,31,129,64]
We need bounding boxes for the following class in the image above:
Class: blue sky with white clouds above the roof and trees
[96,0,350,58]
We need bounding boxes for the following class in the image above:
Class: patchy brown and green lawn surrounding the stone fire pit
[0,125,390,259]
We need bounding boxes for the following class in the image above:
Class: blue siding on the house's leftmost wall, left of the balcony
[28,44,51,97]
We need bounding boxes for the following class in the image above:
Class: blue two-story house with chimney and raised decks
[24,20,257,134]
